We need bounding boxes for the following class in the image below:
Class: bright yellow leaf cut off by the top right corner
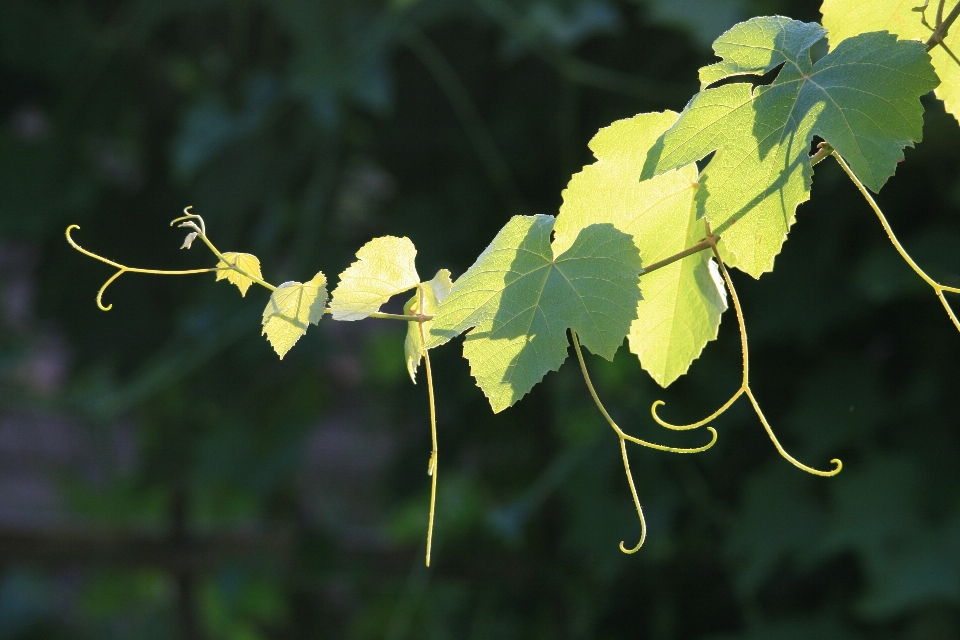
[820,0,960,120]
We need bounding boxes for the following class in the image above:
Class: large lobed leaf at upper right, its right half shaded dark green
[643,17,938,277]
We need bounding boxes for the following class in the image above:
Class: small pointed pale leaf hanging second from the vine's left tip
[263,271,327,360]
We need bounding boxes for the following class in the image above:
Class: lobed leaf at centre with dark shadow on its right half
[427,215,641,412]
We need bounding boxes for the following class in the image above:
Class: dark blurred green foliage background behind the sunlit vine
[0,0,960,640]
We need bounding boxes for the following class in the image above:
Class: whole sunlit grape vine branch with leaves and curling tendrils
[66,0,960,566]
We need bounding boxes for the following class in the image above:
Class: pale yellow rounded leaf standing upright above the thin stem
[330,236,420,320]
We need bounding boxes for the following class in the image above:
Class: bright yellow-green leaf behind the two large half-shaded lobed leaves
[553,111,727,387]
